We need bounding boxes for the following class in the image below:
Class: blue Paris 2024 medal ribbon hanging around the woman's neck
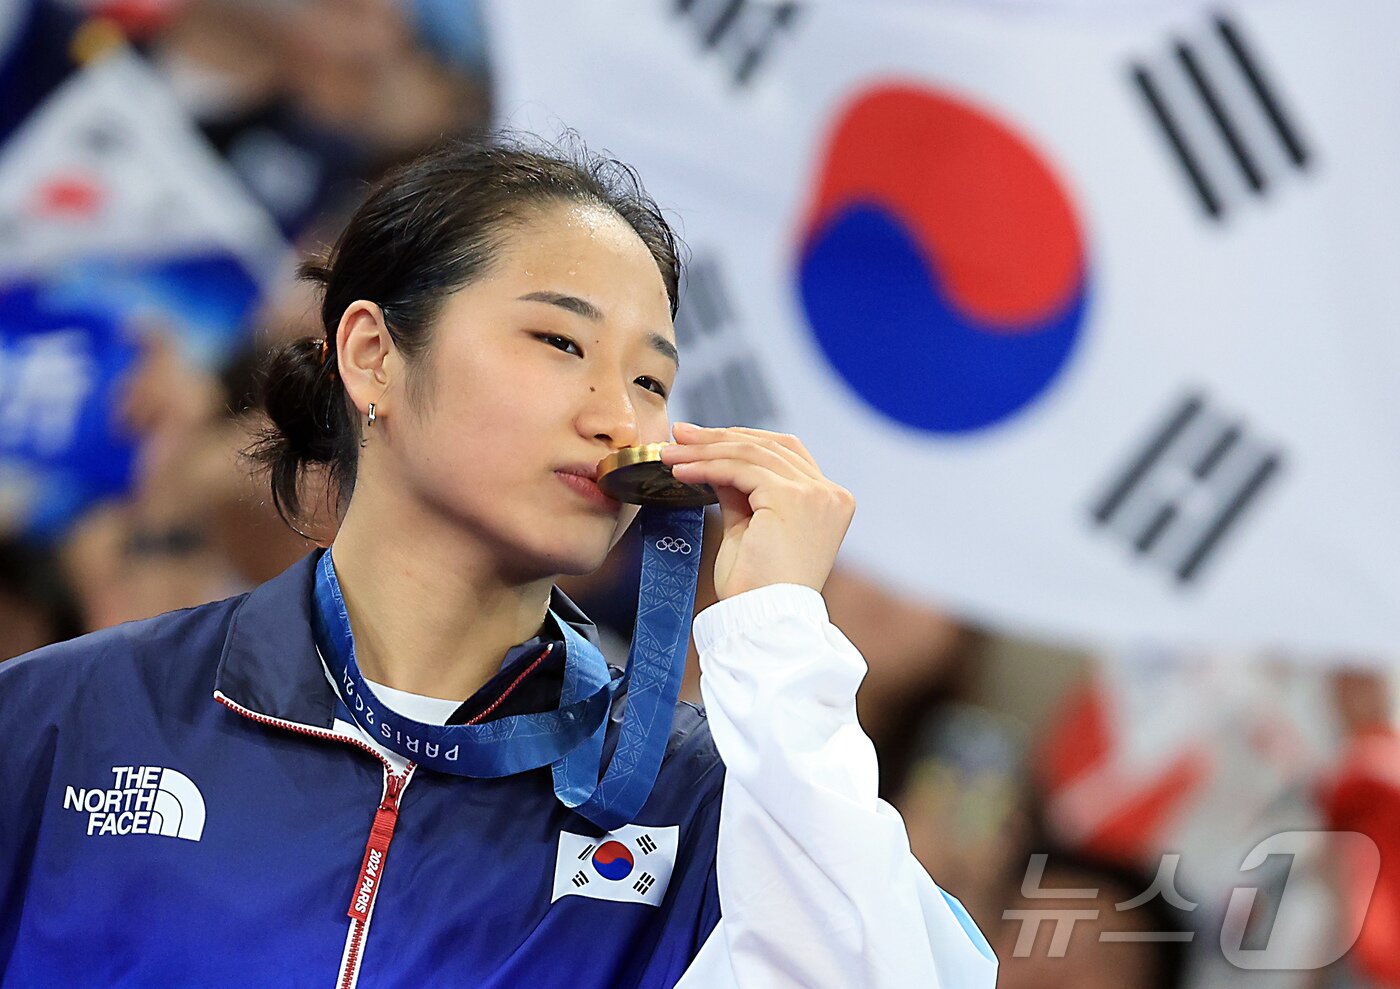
[315,506,704,831]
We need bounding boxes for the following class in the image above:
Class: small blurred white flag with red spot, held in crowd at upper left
[0,50,286,296]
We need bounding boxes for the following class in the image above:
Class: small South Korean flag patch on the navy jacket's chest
[550,824,680,906]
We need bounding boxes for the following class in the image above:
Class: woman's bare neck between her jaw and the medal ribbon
[332,489,553,700]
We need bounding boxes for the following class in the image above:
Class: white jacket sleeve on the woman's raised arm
[678,584,997,989]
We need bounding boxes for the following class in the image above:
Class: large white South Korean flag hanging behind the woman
[489,0,1400,654]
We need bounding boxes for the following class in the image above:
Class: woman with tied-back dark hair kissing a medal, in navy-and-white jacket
[0,134,995,989]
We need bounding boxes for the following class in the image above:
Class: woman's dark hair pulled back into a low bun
[246,134,680,532]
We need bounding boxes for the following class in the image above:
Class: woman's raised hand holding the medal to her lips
[661,423,855,601]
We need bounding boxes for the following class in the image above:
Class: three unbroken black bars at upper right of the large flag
[1131,17,1312,220]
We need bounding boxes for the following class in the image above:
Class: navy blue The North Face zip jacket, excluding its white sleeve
[0,553,724,989]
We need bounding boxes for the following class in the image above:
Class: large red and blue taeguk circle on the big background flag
[798,84,1086,433]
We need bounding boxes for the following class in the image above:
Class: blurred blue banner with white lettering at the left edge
[0,255,258,541]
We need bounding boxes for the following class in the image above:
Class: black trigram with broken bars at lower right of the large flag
[1093,395,1282,584]
